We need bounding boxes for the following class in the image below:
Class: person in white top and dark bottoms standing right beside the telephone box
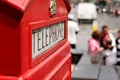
[68,14,79,49]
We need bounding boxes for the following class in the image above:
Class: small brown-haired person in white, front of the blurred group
[104,39,117,66]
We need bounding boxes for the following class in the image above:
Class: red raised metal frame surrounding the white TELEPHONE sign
[29,16,68,67]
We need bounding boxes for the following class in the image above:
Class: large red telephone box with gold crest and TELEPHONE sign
[0,0,71,80]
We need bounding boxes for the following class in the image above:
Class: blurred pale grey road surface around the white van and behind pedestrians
[71,8,120,53]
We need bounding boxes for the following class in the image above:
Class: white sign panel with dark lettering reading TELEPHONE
[32,22,65,59]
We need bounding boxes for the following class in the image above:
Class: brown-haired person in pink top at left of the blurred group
[88,30,103,64]
